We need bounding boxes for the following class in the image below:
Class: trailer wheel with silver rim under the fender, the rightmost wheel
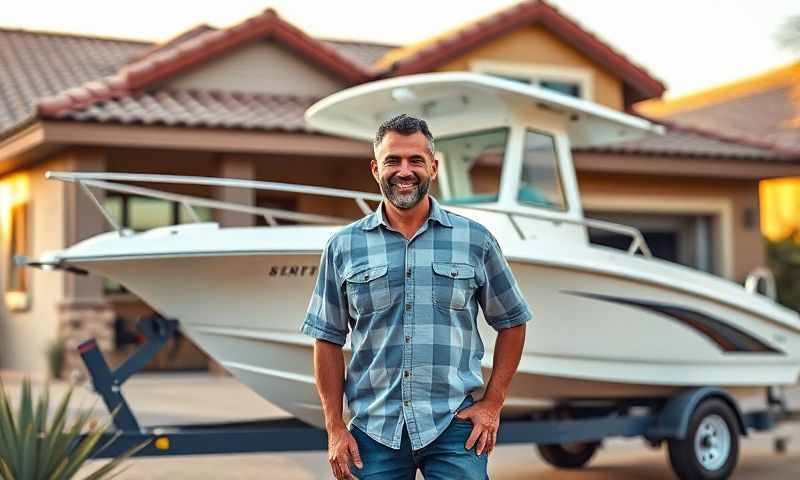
[668,398,739,480]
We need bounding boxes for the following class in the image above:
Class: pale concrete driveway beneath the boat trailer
[4,374,800,480]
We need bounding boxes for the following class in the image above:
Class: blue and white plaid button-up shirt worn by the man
[302,198,531,450]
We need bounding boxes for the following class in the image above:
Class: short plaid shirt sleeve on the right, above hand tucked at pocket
[478,232,533,331]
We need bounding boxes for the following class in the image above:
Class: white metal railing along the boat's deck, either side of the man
[45,171,652,257]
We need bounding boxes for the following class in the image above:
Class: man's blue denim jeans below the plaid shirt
[350,398,489,480]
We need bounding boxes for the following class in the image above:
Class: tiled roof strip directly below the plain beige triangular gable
[52,89,319,132]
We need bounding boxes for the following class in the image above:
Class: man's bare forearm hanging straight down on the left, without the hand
[314,340,344,431]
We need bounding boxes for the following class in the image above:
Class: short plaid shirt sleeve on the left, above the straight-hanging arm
[301,240,349,345]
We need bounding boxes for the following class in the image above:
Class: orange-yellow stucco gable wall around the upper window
[436,26,624,110]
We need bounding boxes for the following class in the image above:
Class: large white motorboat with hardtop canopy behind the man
[29,73,800,426]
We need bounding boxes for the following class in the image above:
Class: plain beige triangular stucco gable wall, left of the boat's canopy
[164,41,344,96]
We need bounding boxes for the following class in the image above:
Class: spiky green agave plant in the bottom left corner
[0,379,146,480]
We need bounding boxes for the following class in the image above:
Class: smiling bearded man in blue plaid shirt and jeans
[302,115,531,480]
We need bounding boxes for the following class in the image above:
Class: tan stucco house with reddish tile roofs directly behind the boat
[0,1,800,371]
